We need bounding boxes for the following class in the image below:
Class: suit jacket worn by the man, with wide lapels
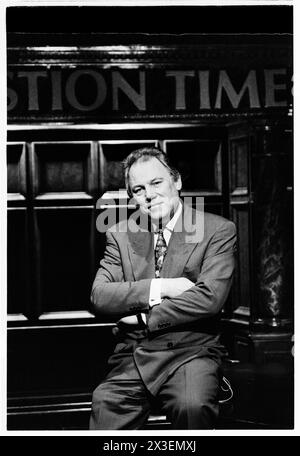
[91,205,236,394]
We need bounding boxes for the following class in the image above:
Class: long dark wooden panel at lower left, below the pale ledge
[7,322,115,396]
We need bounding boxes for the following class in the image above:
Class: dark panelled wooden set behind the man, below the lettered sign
[7,25,293,429]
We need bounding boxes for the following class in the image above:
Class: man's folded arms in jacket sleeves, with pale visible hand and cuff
[91,221,236,331]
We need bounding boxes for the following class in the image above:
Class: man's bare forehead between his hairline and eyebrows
[129,157,171,185]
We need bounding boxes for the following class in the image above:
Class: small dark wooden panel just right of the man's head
[164,140,222,193]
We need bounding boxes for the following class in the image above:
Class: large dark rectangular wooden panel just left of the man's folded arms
[35,208,94,312]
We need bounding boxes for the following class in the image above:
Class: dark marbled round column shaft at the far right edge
[251,123,293,330]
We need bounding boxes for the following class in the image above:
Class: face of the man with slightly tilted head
[128,157,182,224]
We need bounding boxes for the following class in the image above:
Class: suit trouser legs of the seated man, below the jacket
[90,356,221,430]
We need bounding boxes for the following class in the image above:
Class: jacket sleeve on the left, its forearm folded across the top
[91,231,151,320]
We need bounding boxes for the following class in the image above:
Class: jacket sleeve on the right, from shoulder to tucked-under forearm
[147,221,236,332]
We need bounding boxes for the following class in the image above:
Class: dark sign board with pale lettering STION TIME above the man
[7,67,292,118]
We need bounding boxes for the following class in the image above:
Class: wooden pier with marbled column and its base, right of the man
[227,117,293,362]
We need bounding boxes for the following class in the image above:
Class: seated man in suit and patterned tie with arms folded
[90,148,236,429]
